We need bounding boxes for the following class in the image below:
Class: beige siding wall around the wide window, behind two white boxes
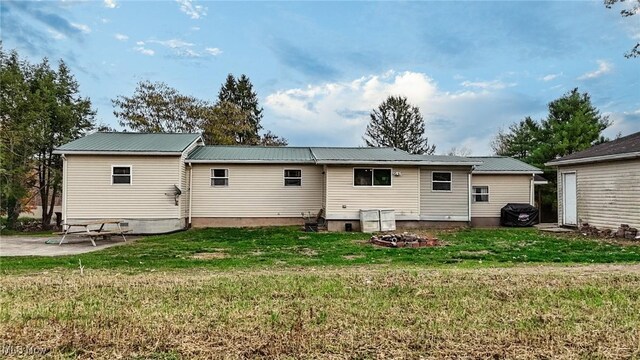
[326,166,420,220]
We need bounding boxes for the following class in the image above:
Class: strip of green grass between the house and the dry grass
[0,227,640,273]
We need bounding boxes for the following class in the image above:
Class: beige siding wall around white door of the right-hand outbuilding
[558,159,640,229]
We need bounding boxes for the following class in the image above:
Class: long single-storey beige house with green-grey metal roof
[56,133,540,233]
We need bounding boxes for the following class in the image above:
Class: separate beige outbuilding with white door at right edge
[545,132,640,229]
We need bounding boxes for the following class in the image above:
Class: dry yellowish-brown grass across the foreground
[0,265,640,359]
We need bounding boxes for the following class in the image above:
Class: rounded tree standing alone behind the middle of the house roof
[364,96,436,155]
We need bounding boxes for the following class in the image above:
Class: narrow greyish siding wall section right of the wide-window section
[420,167,470,221]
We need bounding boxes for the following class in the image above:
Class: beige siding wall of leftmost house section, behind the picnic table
[66,155,180,219]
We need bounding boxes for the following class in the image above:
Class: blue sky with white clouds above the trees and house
[0,0,640,155]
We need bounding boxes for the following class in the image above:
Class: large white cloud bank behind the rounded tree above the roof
[264,71,545,154]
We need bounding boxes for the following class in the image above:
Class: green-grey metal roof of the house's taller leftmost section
[56,132,200,154]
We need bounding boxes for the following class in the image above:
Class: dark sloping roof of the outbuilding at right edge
[545,132,640,166]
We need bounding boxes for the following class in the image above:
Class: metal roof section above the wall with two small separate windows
[187,146,314,163]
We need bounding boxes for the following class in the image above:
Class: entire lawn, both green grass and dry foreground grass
[0,228,640,359]
